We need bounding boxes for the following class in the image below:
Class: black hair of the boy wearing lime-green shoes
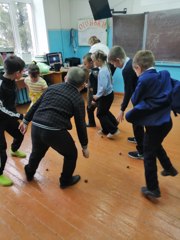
[4,55,25,74]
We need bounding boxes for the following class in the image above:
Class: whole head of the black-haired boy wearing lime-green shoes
[4,55,25,80]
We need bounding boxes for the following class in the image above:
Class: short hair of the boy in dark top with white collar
[108,45,126,61]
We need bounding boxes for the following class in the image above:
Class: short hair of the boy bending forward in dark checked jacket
[67,67,86,88]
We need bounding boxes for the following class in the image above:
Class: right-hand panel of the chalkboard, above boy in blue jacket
[146,9,180,62]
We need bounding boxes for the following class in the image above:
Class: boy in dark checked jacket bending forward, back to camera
[20,67,89,188]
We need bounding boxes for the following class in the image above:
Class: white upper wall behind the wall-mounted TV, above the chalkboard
[43,0,180,29]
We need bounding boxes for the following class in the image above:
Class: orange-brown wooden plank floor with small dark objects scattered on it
[0,96,180,240]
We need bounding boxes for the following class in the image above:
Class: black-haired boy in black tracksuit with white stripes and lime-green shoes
[0,55,26,186]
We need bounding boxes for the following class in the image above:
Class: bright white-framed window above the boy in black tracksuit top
[0,0,47,61]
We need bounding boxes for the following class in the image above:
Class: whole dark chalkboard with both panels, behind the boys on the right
[113,9,180,62]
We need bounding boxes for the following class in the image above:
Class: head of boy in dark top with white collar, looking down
[108,46,126,68]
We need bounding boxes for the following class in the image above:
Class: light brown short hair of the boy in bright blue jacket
[133,50,155,70]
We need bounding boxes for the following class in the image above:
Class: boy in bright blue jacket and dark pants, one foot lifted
[126,51,178,198]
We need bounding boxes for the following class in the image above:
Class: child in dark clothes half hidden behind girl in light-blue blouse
[83,53,99,127]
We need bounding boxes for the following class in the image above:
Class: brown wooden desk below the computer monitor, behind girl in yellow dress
[16,68,68,90]
